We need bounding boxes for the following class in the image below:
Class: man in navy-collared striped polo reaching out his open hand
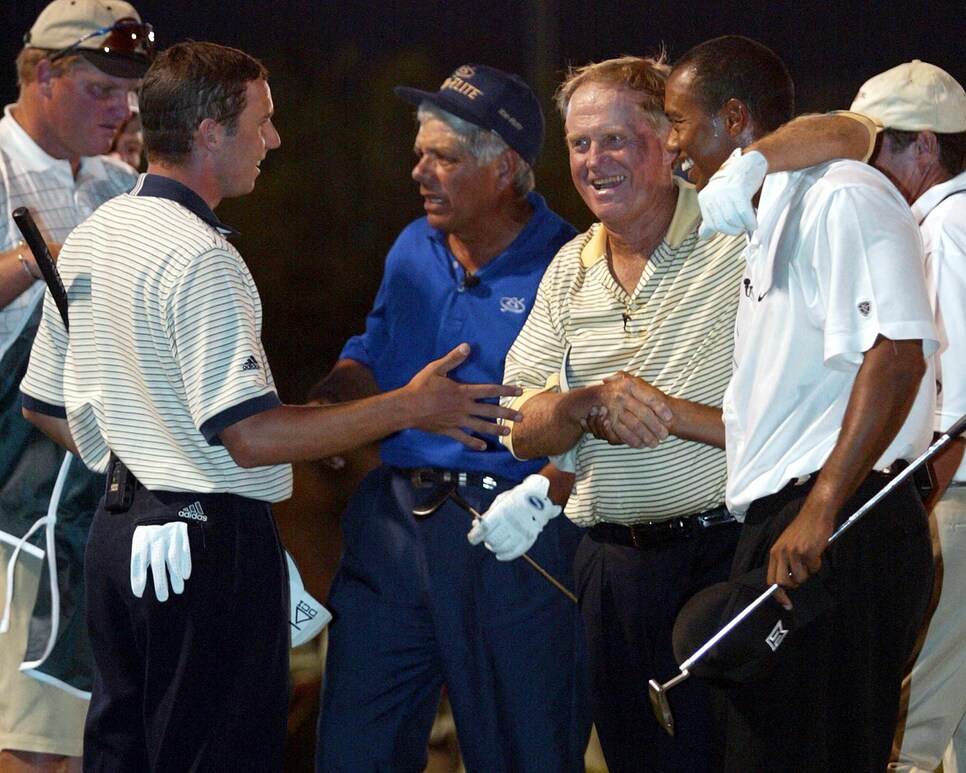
[21,43,513,771]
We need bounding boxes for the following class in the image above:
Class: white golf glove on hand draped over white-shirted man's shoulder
[698,148,768,239]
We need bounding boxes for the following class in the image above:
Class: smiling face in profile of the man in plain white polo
[664,67,737,190]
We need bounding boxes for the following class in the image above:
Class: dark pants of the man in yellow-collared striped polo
[574,522,739,773]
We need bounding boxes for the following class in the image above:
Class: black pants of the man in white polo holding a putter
[722,473,933,773]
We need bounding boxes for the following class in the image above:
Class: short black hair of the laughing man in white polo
[674,35,795,134]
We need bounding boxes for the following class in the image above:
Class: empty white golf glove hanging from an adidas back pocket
[131,521,191,601]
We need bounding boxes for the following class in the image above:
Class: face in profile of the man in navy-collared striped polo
[216,80,281,198]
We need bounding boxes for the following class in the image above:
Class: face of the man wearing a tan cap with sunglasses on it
[38,61,137,162]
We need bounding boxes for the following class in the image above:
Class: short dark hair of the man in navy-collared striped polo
[138,41,268,163]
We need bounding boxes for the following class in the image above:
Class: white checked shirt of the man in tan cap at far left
[0,106,135,356]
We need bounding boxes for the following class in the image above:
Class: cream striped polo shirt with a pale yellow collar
[504,182,744,526]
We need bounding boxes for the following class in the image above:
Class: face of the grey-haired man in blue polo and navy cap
[412,117,500,236]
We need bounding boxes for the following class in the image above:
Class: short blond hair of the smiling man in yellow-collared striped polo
[554,51,671,131]
